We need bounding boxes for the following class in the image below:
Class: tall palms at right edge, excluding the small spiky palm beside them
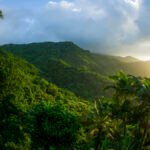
[108,72,150,149]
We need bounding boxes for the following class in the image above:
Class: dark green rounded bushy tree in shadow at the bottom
[29,102,79,149]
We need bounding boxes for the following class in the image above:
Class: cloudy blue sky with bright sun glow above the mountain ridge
[0,0,150,60]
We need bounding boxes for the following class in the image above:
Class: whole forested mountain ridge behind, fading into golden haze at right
[1,42,150,99]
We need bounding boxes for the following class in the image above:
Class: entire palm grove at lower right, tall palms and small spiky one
[81,72,150,150]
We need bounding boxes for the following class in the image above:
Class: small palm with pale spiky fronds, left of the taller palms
[90,98,114,150]
